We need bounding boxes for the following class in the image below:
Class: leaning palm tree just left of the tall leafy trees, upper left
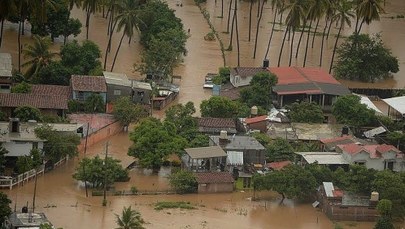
[111,0,141,71]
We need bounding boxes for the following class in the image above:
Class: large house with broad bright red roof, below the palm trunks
[269,67,350,110]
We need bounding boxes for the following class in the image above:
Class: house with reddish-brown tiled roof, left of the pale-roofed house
[70,75,107,103]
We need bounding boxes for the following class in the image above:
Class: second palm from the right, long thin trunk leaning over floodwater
[329,0,354,74]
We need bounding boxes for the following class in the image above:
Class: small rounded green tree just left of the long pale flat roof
[266,138,294,161]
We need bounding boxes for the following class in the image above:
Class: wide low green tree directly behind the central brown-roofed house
[200,96,238,118]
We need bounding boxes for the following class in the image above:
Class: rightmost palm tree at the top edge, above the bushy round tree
[356,0,384,33]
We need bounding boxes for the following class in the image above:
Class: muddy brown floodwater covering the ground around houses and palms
[0,0,405,229]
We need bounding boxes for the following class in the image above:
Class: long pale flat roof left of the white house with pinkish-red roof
[295,152,349,165]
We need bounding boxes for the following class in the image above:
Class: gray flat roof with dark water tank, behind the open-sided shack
[210,135,265,150]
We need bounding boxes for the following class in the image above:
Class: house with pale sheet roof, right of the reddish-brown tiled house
[103,71,133,103]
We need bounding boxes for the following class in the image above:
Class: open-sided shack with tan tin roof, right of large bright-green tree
[182,146,227,172]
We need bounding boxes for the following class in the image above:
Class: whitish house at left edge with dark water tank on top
[0,118,45,157]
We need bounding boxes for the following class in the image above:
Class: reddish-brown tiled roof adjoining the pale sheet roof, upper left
[70,75,107,92]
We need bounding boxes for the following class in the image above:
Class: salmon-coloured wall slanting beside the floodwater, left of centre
[77,122,123,152]
